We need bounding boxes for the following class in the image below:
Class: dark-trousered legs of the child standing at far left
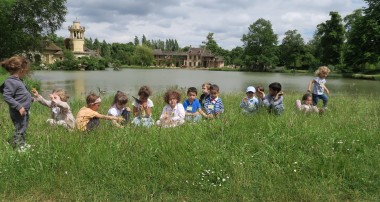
[9,109,29,148]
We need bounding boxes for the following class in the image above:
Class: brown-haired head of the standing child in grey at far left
[1,56,29,77]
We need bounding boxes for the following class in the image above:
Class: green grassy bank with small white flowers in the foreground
[0,94,380,201]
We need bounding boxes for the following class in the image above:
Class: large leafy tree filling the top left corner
[0,0,67,58]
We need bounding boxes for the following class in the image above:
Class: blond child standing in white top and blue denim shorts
[307,66,330,109]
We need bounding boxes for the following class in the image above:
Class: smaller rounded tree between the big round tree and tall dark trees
[280,30,305,67]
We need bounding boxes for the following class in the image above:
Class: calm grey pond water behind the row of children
[33,69,380,97]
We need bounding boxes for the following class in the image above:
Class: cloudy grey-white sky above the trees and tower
[56,0,367,50]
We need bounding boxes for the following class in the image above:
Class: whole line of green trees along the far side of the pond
[0,0,380,73]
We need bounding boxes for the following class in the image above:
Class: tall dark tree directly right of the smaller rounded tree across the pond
[317,12,344,65]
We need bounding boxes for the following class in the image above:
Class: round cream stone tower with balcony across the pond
[69,20,86,53]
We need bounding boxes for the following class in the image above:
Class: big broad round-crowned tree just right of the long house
[241,18,278,71]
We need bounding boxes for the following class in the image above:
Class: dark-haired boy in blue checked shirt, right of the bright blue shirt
[204,84,224,118]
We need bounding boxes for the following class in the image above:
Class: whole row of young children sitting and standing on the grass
[0,56,330,150]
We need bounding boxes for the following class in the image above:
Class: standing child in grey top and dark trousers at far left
[1,56,32,152]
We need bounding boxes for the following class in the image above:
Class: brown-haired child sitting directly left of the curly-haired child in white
[132,86,154,127]
